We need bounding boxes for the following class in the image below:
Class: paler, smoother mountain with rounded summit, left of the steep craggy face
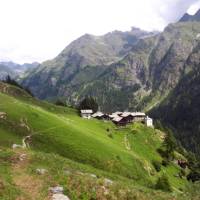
[23,28,155,103]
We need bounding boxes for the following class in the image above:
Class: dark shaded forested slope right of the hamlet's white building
[151,67,200,156]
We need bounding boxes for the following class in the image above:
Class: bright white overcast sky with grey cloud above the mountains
[0,0,200,63]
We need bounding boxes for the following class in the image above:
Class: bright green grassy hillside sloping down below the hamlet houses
[0,83,198,199]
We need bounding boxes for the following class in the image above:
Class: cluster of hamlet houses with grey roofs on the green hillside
[81,110,153,127]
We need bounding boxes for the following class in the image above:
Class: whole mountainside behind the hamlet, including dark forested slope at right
[22,13,200,154]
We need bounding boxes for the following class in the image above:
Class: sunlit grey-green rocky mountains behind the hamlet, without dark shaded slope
[23,22,200,112]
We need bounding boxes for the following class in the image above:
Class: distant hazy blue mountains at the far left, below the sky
[0,61,39,80]
